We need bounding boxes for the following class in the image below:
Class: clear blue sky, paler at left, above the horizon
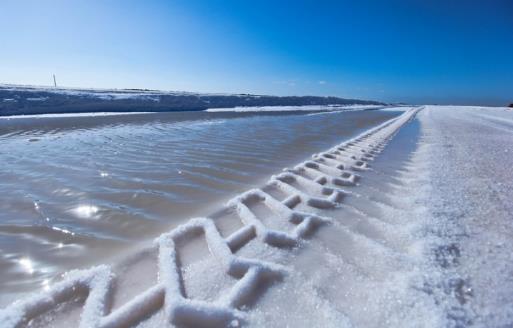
[0,0,513,105]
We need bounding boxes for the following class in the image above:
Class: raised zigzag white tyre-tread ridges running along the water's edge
[0,108,420,328]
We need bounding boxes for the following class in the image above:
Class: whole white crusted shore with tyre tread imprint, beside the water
[0,106,513,327]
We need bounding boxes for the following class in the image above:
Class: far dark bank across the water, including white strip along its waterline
[0,84,382,115]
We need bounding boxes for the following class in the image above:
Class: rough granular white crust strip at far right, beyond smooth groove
[408,106,513,327]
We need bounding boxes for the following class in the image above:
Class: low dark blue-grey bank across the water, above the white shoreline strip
[0,85,384,116]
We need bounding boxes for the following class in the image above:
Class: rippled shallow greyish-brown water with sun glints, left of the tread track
[0,111,399,305]
